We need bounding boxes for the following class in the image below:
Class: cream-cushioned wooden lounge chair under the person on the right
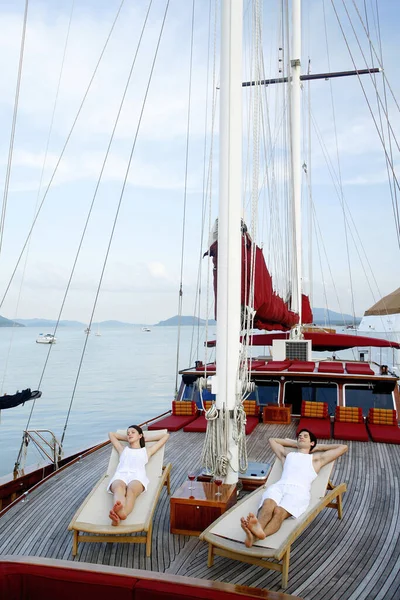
[200,459,346,588]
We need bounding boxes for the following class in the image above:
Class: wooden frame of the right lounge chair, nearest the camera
[200,459,347,589]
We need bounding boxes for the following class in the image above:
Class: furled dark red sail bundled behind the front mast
[208,233,313,331]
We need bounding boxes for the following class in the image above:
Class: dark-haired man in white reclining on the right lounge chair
[240,429,347,548]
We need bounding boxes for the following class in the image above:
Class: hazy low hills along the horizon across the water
[0,308,361,331]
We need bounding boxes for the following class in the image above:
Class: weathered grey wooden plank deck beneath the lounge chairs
[0,422,400,600]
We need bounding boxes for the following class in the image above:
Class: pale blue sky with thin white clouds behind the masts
[0,0,400,323]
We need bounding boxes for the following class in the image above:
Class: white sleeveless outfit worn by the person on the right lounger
[259,452,317,519]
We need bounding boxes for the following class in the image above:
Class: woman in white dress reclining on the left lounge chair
[107,425,169,526]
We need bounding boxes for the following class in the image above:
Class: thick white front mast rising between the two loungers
[216,0,243,483]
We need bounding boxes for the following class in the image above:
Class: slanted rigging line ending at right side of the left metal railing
[60,0,170,449]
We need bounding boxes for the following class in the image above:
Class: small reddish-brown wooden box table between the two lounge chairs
[170,481,237,535]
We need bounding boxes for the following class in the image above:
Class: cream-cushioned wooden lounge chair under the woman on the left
[68,429,172,556]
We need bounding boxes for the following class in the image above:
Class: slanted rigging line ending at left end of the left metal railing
[22,0,153,429]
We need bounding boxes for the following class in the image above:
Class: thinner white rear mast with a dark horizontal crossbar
[290,0,302,325]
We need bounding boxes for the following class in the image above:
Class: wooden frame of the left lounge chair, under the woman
[68,430,172,557]
